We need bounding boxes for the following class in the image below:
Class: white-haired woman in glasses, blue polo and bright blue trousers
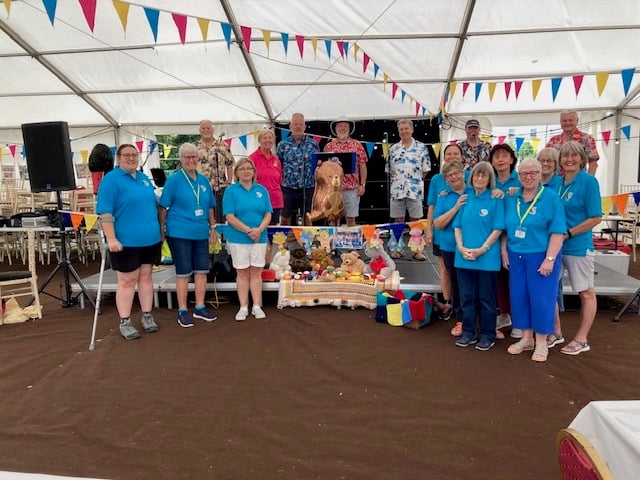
[502,158,566,362]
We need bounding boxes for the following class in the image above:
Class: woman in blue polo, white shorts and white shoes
[222,158,273,321]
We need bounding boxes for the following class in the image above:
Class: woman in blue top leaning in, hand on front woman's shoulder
[433,160,467,337]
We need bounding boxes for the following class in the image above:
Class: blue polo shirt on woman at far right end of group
[558,170,602,257]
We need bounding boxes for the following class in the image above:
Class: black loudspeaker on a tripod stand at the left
[22,122,76,192]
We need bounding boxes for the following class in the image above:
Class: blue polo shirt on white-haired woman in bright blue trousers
[504,187,567,253]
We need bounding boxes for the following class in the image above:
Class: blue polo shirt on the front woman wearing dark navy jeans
[453,189,504,271]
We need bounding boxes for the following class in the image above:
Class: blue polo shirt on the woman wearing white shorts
[222,183,273,243]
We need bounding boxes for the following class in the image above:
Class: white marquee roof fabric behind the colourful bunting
[0,0,640,133]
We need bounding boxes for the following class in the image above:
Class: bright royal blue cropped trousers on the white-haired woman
[509,250,562,335]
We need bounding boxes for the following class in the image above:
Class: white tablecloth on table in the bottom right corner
[569,400,640,480]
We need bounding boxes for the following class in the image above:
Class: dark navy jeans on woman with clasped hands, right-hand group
[457,268,498,341]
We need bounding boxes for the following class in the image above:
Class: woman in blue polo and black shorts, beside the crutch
[96,143,161,340]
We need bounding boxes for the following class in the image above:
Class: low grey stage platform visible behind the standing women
[71,249,640,308]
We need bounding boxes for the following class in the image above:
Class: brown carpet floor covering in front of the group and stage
[0,253,640,480]
